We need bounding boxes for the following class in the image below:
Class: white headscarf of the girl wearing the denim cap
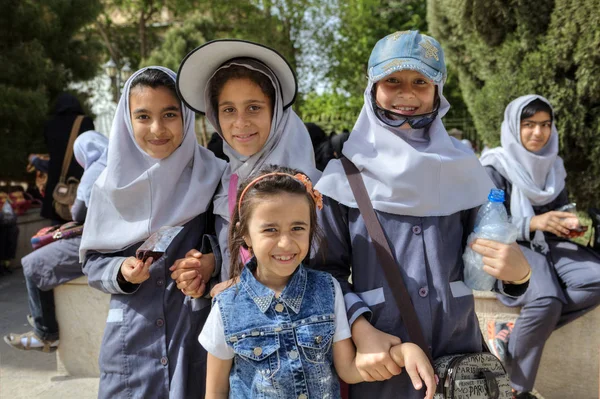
[316,82,494,216]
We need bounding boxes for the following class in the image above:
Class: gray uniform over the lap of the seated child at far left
[21,200,87,291]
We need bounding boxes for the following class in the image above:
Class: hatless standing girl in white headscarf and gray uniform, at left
[80,67,225,398]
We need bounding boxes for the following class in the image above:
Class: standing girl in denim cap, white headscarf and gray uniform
[315,31,530,399]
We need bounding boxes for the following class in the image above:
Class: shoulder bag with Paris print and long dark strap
[342,158,512,399]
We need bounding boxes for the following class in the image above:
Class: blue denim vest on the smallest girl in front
[216,259,340,399]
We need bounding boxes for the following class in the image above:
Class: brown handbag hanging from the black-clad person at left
[52,115,83,220]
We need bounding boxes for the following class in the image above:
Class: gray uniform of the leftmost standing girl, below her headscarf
[83,214,210,399]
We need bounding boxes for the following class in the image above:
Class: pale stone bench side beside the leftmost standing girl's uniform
[54,276,110,377]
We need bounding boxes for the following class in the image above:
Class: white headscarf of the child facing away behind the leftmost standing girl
[73,130,108,206]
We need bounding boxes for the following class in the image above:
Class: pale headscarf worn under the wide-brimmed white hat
[204,58,321,221]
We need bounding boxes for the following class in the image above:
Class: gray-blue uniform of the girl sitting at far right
[486,166,600,392]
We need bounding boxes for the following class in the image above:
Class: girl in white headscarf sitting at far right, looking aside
[481,95,600,399]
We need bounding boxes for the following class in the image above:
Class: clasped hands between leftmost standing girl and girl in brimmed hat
[169,249,215,298]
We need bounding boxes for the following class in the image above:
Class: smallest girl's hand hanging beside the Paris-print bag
[390,342,437,399]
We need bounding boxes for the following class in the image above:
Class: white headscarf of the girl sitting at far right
[481,94,567,253]
